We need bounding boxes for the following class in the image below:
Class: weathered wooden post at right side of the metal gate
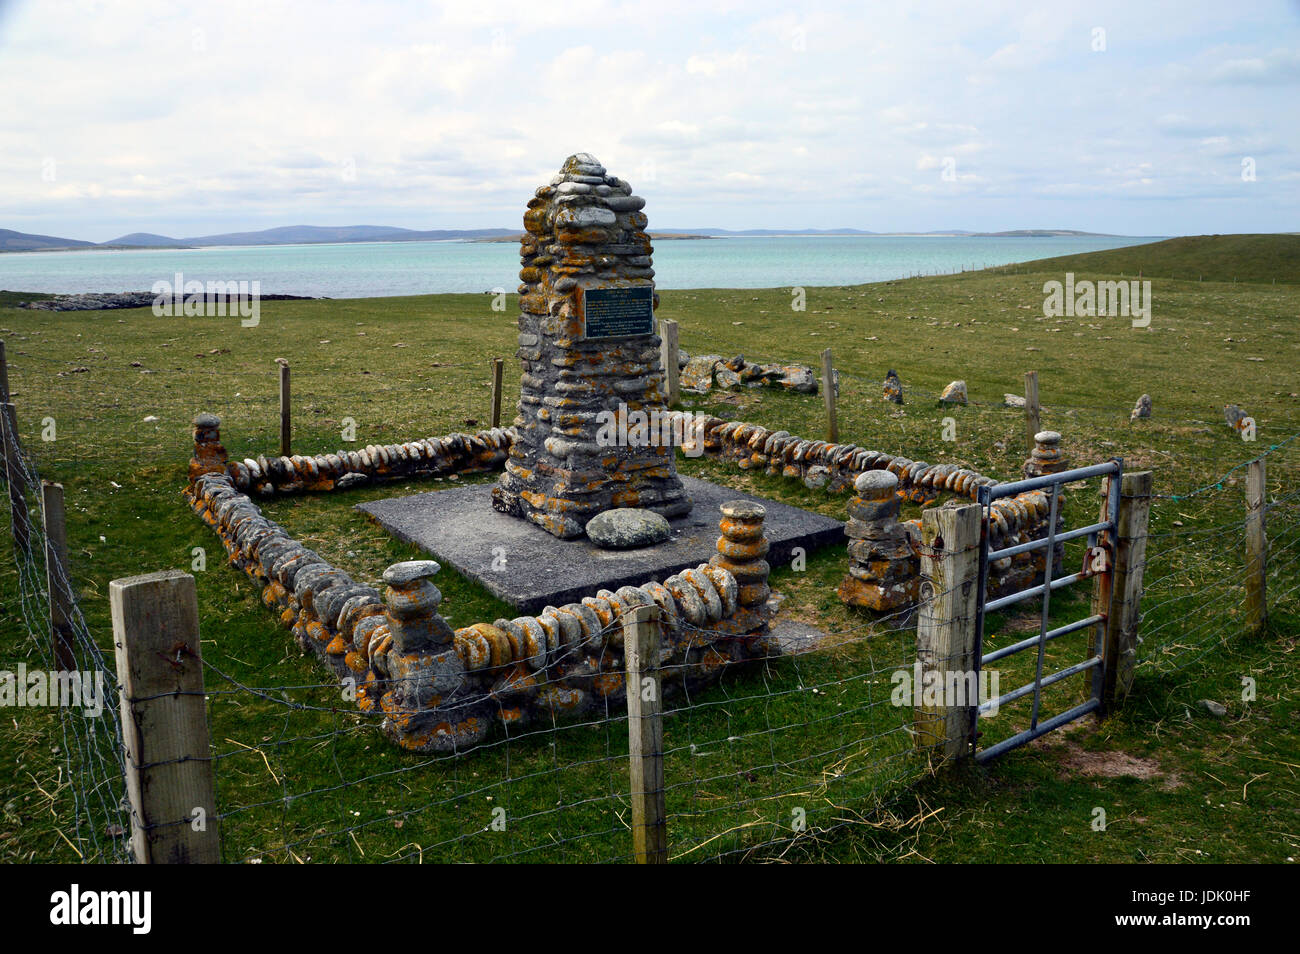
[1092,471,1154,715]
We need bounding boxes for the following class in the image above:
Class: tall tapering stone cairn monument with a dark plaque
[493,152,692,538]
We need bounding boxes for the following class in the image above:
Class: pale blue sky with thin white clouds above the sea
[0,0,1300,242]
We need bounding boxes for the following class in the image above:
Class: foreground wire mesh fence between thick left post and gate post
[185,605,927,862]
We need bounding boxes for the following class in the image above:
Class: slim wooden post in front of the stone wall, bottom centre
[623,606,668,864]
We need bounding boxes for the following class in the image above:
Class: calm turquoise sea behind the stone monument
[0,235,1157,298]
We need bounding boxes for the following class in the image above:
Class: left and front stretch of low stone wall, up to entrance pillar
[186,416,779,753]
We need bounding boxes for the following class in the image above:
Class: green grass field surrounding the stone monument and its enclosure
[0,237,1300,862]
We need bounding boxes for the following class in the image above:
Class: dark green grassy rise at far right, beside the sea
[992,233,1300,282]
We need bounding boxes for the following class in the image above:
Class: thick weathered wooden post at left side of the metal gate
[913,503,983,759]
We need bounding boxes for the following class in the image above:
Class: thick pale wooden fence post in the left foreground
[108,571,221,864]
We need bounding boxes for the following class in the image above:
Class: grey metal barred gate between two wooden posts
[972,459,1123,762]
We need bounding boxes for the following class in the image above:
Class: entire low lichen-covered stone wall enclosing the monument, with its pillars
[186,397,1069,738]
